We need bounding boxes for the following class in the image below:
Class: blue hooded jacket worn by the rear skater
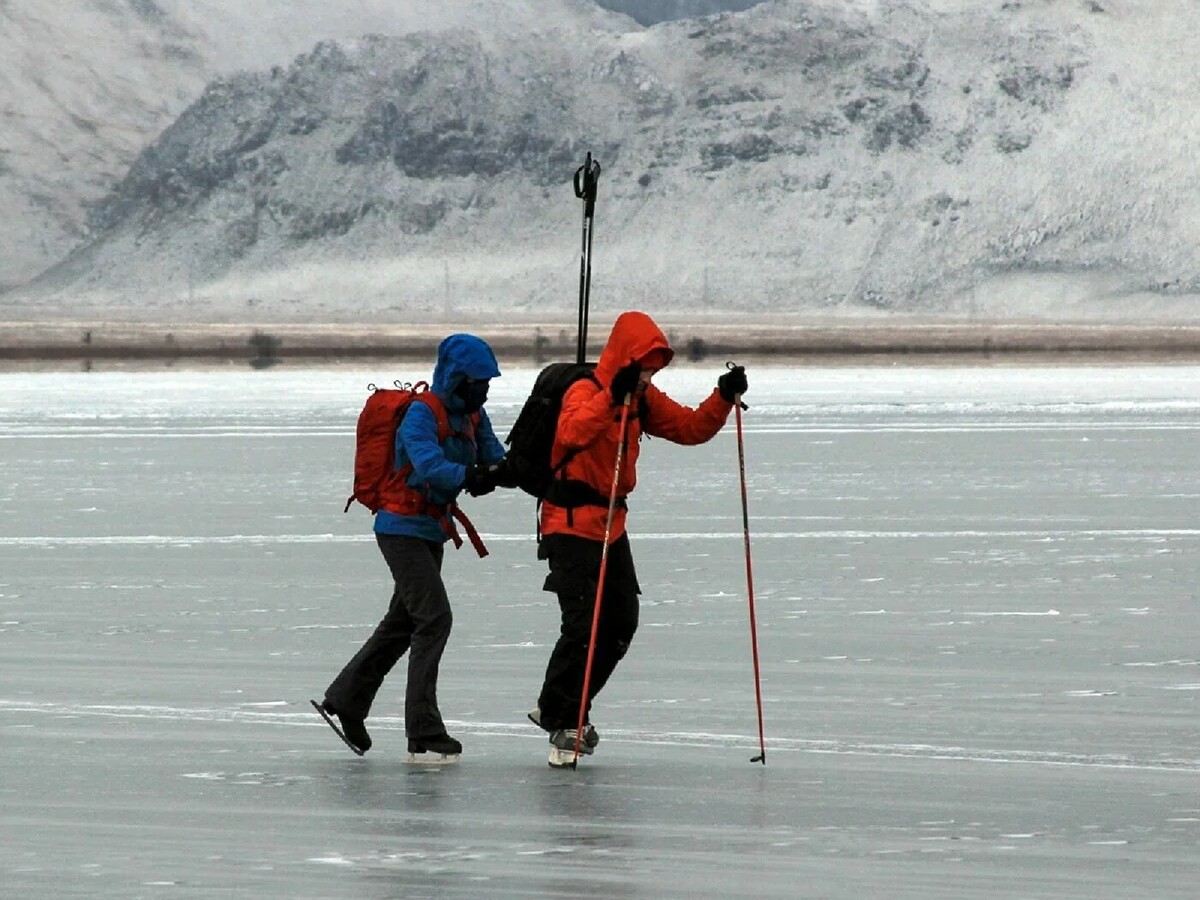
[374,335,504,542]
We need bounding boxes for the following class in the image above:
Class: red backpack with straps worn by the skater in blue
[342,382,487,556]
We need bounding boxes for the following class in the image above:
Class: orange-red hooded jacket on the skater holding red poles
[541,312,733,541]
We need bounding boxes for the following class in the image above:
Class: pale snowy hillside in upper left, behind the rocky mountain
[0,0,636,290]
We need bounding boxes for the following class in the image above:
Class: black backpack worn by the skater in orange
[504,362,595,499]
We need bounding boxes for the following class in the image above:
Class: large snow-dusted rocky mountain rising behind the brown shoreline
[0,0,1200,320]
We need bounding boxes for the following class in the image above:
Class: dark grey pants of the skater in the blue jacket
[325,534,454,738]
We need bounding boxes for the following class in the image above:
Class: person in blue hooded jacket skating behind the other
[322,335,504,761]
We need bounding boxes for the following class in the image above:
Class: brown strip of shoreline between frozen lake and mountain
[7,319,1200,365]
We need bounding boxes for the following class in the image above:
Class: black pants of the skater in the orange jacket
[538,534,641,731]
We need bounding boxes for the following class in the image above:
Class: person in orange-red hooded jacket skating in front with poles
[529,312,746,766]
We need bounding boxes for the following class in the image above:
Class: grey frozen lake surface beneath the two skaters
[0,364,1200,900]
